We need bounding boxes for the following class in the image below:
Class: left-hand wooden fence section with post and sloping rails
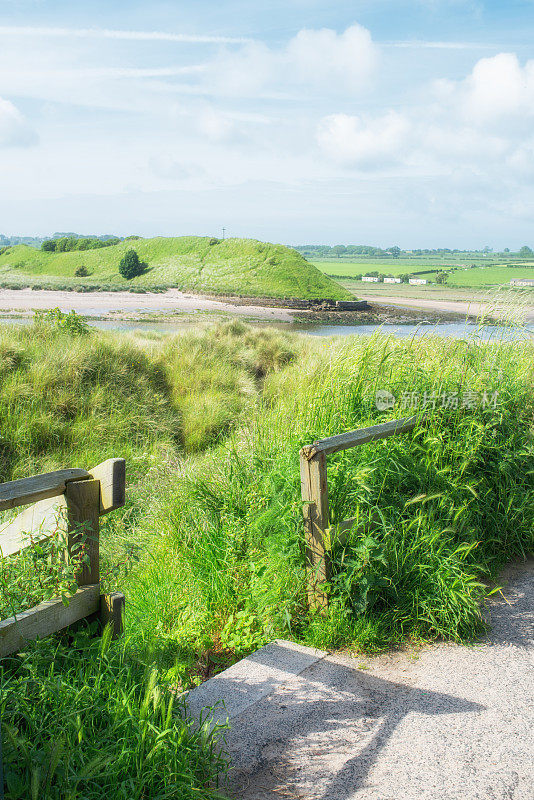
[0,458,126,658]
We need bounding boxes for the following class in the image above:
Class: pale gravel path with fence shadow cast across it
[191,562,534,800]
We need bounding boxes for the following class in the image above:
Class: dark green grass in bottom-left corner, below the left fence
[0,631,226,800]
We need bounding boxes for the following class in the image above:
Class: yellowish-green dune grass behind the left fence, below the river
[0,316,300,480]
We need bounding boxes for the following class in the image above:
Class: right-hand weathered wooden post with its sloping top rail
[300,416,422,609]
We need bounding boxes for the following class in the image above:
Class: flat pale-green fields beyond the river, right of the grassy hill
[312,258,534,287]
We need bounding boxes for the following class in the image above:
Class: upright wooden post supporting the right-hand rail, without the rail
[300,450,331,611]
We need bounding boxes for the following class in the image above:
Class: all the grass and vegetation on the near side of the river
[0,316,534,800]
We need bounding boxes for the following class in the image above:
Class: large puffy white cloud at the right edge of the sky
[316,53,534,184]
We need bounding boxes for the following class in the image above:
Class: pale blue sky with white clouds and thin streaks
[0,0,534,249]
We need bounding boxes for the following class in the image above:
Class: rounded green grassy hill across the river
[0,236,353,300]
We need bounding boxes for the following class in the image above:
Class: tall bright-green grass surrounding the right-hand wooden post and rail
[126,326,534,664]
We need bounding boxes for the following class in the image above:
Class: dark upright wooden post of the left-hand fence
[65,480,100,586]
